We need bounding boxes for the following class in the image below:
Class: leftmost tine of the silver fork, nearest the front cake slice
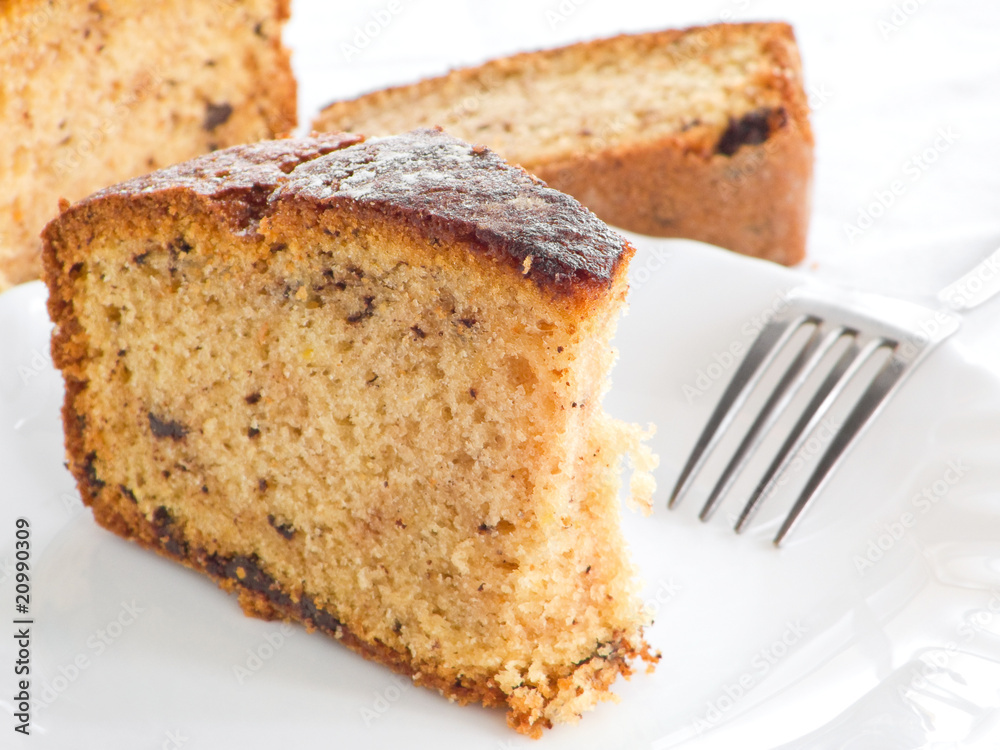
[667,314,816,508]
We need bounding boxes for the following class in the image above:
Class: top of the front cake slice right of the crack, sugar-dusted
[276,129,632,293]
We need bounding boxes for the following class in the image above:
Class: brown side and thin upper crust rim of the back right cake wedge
[313,23,813,265]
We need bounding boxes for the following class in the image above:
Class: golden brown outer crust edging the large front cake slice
[44,126,649,735]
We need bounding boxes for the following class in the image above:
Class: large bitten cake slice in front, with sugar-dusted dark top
[44,130,654,735]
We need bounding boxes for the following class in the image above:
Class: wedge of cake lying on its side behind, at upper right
[313,23,813,264]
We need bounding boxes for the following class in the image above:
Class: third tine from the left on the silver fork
[735,334,887,533]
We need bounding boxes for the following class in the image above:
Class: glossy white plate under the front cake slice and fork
[0,238,1000,750]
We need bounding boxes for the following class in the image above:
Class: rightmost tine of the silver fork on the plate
[774,353,906,547]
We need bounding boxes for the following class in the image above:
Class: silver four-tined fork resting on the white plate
[668,249,1000,546]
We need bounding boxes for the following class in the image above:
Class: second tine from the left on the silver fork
[698,323,848,521]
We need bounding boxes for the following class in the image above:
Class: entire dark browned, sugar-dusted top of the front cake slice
[45,129,634,299]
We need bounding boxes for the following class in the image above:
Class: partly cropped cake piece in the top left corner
[0,0,296,291]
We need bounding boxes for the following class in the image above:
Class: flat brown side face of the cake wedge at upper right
[535,119,812,265]
